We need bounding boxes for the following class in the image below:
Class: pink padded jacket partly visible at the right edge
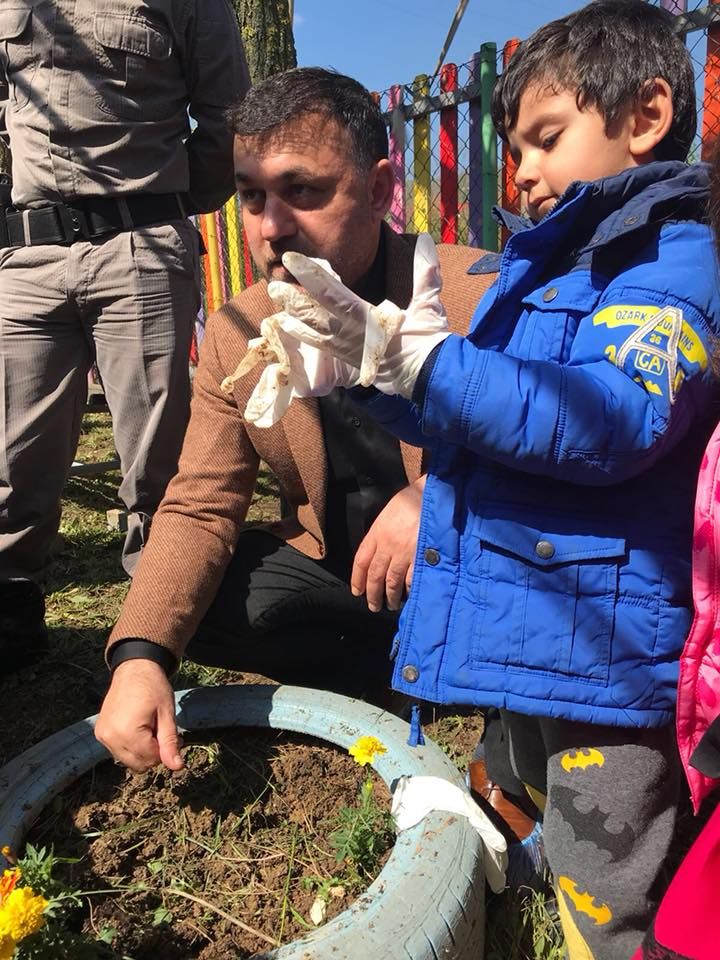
[677,427,720,811]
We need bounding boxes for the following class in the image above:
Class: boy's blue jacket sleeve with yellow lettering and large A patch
[408,223,720,485]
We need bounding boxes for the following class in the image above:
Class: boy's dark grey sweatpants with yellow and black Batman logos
[501,711,680,960]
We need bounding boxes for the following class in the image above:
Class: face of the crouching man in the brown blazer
[234,114,385,285]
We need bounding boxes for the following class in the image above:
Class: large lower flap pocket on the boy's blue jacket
[471,519,626,683]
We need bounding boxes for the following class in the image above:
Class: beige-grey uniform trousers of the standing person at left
[0,220,200,581]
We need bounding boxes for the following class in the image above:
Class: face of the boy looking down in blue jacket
[508,84,638,221]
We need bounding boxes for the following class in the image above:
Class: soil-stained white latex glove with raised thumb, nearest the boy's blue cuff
[269,233,448,397]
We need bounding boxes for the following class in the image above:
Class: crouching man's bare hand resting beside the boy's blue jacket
[350,477,425,613]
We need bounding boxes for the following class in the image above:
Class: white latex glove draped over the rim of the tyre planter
[391,777,508,893]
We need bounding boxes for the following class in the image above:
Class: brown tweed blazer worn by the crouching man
[108,229,494,656]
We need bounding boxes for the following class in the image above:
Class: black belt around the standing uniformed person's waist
[0,193,188,247]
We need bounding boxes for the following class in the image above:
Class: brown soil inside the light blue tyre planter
[29,729,390,960]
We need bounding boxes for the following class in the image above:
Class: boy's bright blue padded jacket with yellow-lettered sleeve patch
[367,162,720,726]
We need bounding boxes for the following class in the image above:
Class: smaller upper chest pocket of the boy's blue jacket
[507,283,599,363]
